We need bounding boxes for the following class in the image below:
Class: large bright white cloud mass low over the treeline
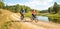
[6,0,53,10]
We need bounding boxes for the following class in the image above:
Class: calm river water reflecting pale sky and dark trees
[37,16,60,23]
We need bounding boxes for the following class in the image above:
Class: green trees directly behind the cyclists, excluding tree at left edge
[5,4,31,13]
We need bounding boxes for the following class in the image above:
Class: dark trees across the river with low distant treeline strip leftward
[40,2,60,14]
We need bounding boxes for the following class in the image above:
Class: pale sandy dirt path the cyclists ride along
[12,14,60,29]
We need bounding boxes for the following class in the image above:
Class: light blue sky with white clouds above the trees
[4,0,60,10]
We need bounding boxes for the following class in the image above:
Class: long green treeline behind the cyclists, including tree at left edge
[0,0,38,13]
